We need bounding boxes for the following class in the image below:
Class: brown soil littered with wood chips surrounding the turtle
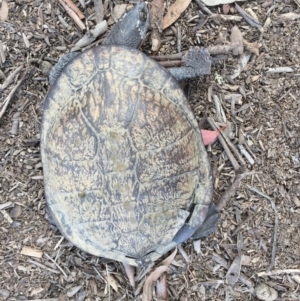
[0,0,300,301]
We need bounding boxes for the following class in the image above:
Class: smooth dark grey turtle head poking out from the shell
[102,2,150,48]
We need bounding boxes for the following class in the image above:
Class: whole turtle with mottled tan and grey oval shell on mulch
[40,2,218,267]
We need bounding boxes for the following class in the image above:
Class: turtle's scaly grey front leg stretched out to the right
[168,46,211,81]
